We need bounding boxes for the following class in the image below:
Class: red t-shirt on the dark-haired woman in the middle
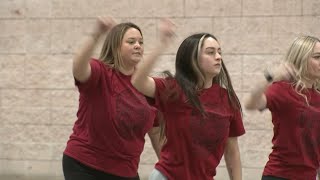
[155,78,245,180]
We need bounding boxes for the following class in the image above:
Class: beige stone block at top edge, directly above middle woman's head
[185,0,242,17]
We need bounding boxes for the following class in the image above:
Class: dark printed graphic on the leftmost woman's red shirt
[115,89,149,140]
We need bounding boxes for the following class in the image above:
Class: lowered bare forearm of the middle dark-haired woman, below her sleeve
[224,137,242,180]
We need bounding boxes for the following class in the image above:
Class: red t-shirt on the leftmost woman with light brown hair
[64,59,156,177]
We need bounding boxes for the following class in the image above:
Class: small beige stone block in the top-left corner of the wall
[0,0,26,18]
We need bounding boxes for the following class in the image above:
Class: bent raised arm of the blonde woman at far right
[244,64,295,110]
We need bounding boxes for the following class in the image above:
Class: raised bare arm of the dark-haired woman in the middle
[131,20,174,98]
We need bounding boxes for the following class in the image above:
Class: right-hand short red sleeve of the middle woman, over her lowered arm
[229,111,245,137]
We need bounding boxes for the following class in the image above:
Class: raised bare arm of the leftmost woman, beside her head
[72,17,115,82]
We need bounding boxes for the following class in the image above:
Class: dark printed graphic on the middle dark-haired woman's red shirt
[190,103,230,159]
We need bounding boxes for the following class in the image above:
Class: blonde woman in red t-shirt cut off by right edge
[246,36,320,180]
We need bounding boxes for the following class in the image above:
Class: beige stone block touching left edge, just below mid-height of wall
[1,89,50,107]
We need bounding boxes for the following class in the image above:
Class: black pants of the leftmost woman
[62,155,140,180]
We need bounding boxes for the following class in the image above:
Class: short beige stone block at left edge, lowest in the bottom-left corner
[0,159,27,175]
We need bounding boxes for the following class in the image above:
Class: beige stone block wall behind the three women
[0,0,320,180]
